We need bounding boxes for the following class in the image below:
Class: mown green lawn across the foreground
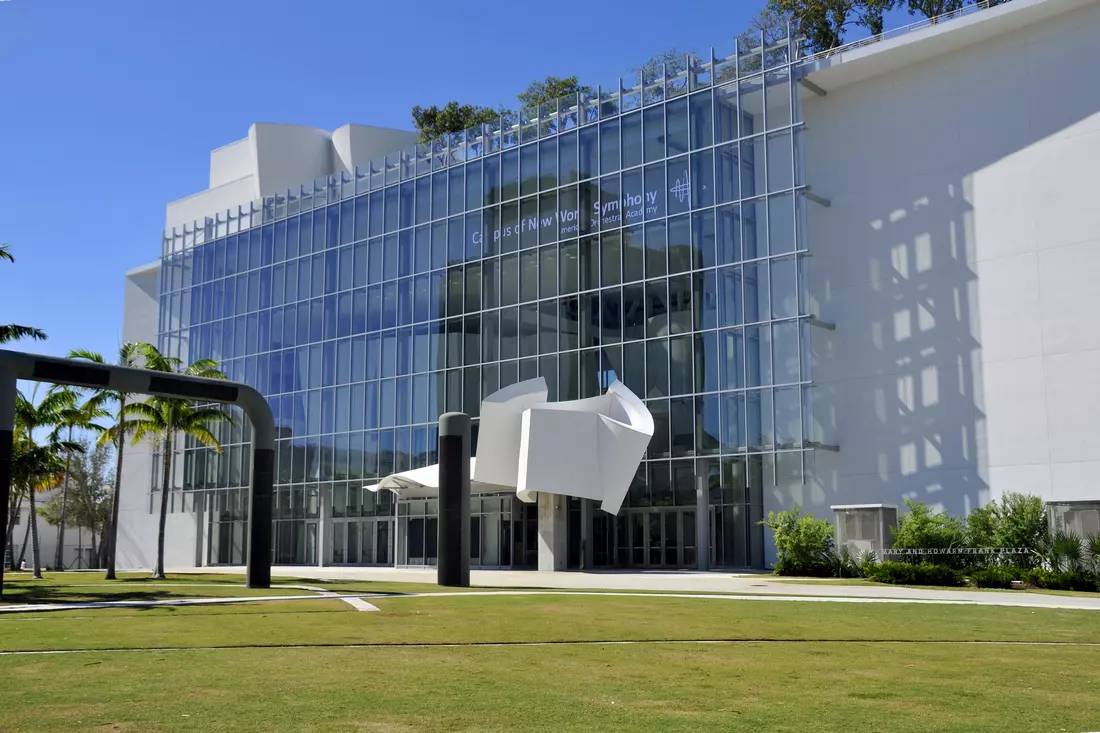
[0,573,1100,732]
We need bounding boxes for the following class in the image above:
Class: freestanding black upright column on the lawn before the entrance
[436,413,470,588]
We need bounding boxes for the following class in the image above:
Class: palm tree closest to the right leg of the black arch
[127,343,233,578]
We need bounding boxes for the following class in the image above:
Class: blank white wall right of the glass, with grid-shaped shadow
[805,0,1100,514]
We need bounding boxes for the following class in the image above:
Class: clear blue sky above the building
[0,0,910,363]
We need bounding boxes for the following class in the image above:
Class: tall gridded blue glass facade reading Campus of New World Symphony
[160,31,810,567]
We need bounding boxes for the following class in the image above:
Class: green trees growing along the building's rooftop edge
[413,0,1008,142]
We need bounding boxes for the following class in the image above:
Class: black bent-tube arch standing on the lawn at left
[0,349,275,594]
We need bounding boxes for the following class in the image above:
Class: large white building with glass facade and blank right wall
[119,0,1100,569]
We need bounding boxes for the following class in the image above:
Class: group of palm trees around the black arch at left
[0,244,232,580]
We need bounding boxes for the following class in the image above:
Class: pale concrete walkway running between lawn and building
[184,566,1100,611]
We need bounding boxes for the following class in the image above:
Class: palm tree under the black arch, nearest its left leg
[12,386,81,578]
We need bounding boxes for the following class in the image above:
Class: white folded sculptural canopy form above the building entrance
[366,376,653,514]
